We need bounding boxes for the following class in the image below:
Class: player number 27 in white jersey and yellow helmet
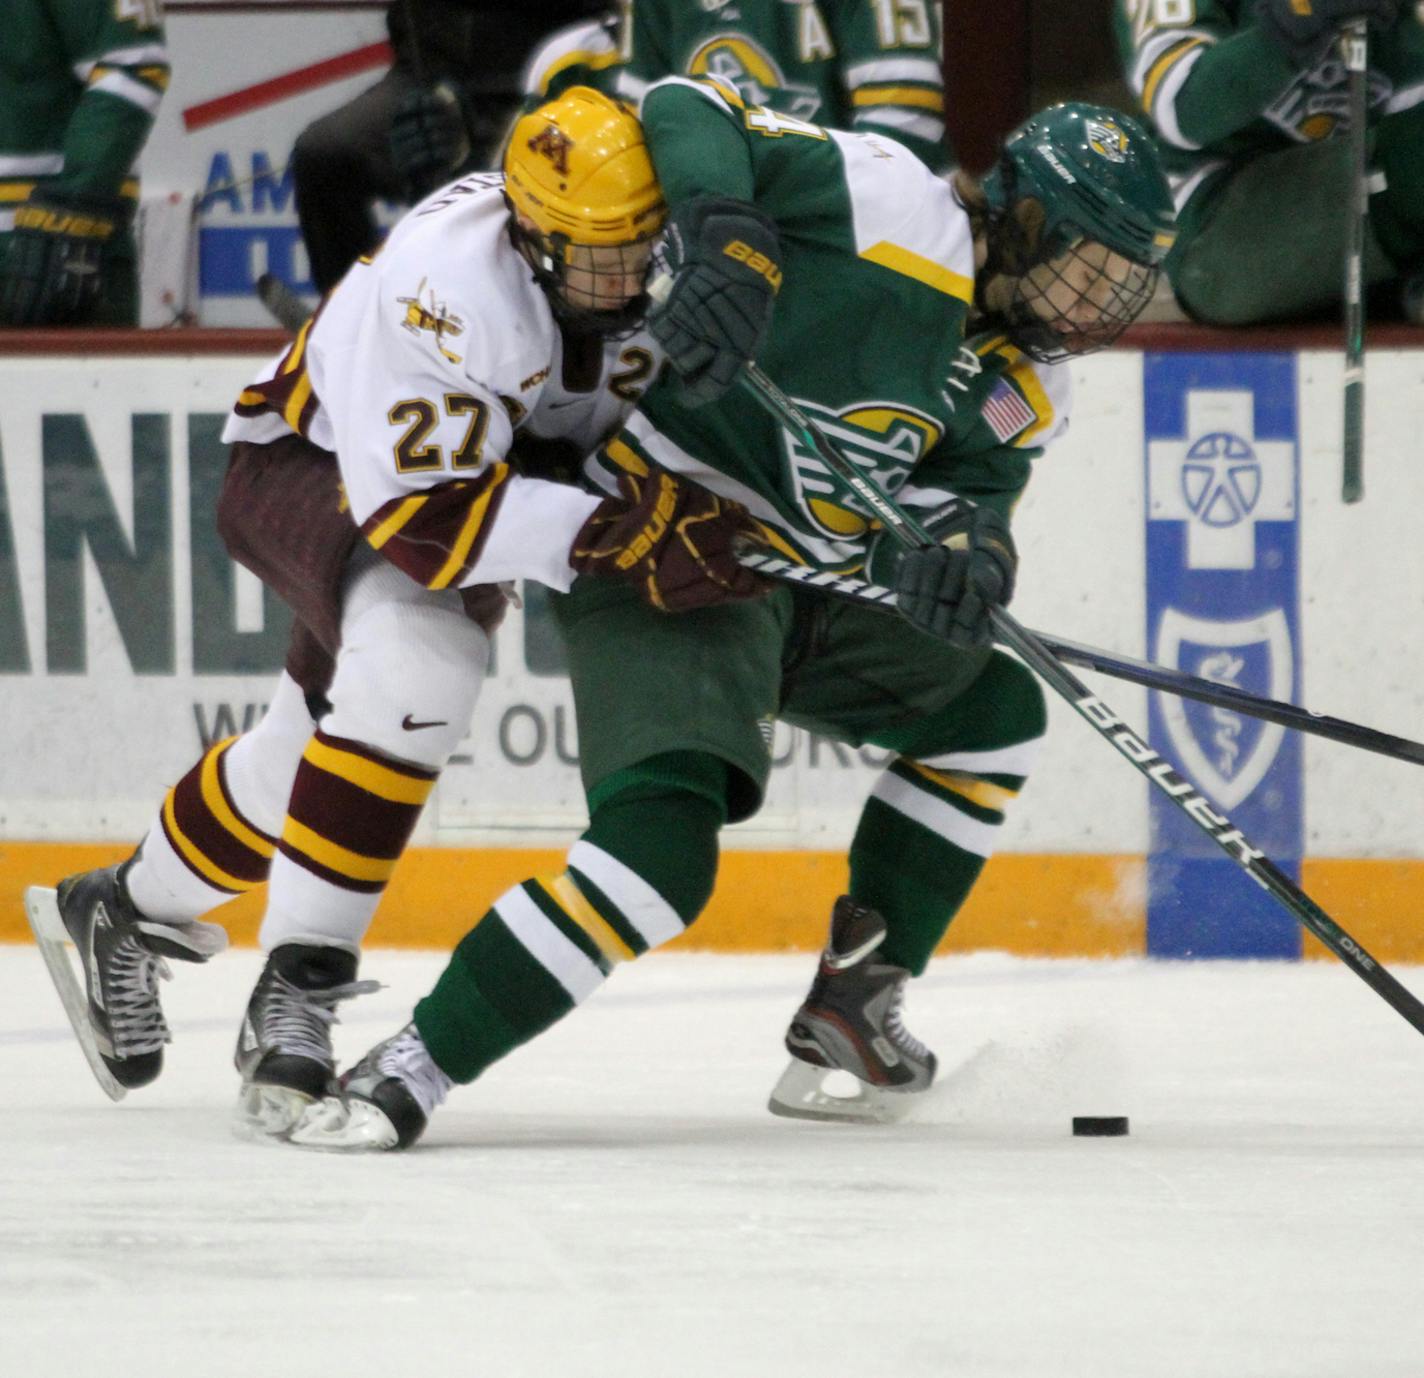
[27,88,759,1133]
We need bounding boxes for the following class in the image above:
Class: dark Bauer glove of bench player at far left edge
[0,188,128,326]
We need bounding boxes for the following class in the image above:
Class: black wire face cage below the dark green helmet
[1004,230,1161,363]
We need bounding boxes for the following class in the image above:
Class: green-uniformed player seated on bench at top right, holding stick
[1115,0,1424,325]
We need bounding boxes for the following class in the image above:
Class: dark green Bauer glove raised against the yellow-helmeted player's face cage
[648,196,782,407]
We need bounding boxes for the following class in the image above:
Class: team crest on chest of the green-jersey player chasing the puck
[782,401,943,541]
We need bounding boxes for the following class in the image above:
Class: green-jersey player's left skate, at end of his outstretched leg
[292,1024,453,1152]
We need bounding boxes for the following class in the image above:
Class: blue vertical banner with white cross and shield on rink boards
[1143,354,1303,957]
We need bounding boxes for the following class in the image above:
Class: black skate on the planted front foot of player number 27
[232,942,380,1139]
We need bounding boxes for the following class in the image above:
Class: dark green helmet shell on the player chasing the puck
[984,102,1176,265]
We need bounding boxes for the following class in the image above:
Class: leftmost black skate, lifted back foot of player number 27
[24,861,228,1100]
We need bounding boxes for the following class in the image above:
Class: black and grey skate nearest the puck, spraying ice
[768,895,936,1120]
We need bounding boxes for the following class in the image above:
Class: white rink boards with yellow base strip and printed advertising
[0,327,1424,959]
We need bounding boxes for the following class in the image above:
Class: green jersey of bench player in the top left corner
[0,0,168,306]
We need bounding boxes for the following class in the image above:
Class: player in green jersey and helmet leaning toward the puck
[292,78,1173,1149]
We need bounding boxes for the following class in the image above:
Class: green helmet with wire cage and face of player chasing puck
[980,102,1176,360]
